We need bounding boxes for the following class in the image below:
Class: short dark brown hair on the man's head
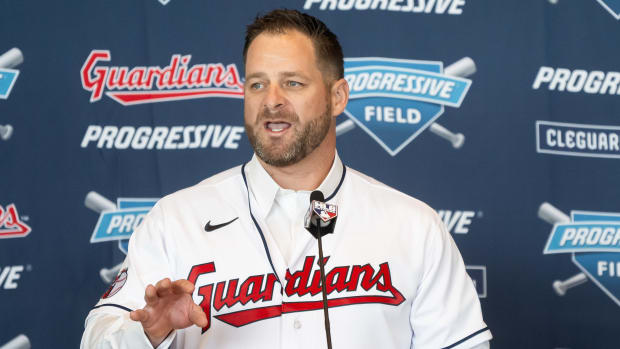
[243,9,344,79]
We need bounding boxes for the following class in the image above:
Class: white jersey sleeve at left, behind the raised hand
[80,201,175,349]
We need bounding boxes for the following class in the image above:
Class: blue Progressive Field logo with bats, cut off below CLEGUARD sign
[538,203,620,306]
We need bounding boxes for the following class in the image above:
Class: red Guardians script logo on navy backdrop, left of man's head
[80,50,243,106]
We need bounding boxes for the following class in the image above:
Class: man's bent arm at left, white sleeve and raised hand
[81,203,207,349]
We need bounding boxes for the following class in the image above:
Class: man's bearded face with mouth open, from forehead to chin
[244,30,333,166]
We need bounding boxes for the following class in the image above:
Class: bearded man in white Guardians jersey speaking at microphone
[82,10,491,349]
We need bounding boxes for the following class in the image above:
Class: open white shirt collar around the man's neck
[245,152,345,213]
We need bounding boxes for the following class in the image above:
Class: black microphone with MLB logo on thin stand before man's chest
[304,190,338,349]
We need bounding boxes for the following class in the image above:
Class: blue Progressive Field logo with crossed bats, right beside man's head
[337,57,476,156]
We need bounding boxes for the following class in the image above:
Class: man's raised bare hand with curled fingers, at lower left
[129,278,208,347]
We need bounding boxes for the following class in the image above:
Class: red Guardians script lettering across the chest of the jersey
[187,256,405,333]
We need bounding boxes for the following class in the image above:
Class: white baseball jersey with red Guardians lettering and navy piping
[82,156,491,349]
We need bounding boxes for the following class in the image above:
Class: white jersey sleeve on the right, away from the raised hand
[410,212,492,349]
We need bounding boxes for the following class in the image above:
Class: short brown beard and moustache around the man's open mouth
[245,103,332,167]
